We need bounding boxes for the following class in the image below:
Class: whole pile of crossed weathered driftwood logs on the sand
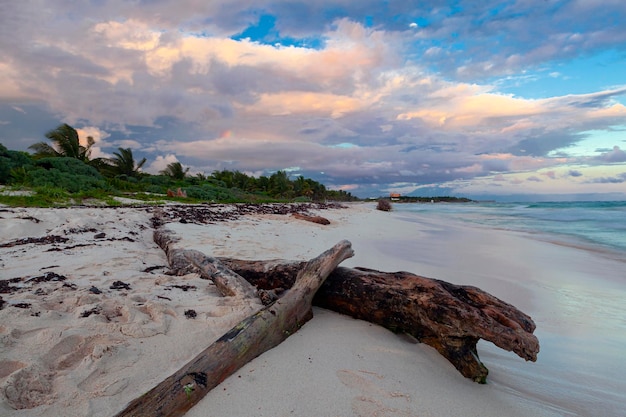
[116,206,539,417]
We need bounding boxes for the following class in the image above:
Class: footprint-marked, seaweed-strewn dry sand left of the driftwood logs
[0,208,256,416]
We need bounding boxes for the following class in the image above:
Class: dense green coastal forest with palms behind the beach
[0,124,357,206]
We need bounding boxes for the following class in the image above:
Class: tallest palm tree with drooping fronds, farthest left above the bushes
[29,123,96,162]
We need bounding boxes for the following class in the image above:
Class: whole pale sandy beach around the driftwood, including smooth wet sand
[0,204,626,417]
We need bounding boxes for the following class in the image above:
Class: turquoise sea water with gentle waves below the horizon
[393,201,626,252]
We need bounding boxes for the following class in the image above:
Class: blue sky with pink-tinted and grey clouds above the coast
[0,0,626,200]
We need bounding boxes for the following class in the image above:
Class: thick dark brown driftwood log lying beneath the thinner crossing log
[221,258,539,383]
